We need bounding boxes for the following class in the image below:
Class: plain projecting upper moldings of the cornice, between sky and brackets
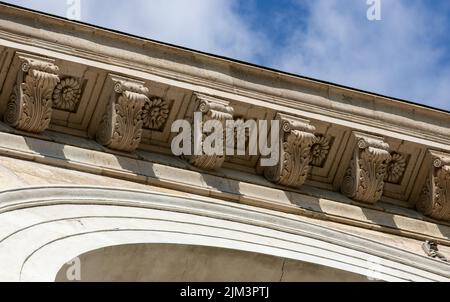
[0,5,450,145]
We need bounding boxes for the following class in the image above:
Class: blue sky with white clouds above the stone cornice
[5,0,450,110]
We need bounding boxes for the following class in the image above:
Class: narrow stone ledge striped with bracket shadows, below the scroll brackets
[0,133,450,246]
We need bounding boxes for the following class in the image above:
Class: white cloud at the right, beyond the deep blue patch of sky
[272,0,450,109]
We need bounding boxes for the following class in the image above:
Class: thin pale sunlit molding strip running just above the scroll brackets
[0,39,450,152]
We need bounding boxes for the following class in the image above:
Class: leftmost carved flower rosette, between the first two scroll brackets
[53,78,81,112]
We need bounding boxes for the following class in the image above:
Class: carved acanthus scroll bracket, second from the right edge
[341,134,391,203]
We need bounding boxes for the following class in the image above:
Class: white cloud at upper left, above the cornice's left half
[3,0,267,61]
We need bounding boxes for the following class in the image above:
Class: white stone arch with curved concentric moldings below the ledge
[0,186,450,281]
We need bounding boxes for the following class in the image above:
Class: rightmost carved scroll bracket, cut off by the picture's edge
[416,154,450,221]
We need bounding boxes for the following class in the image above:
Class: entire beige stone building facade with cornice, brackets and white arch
[0,4,450,281]
